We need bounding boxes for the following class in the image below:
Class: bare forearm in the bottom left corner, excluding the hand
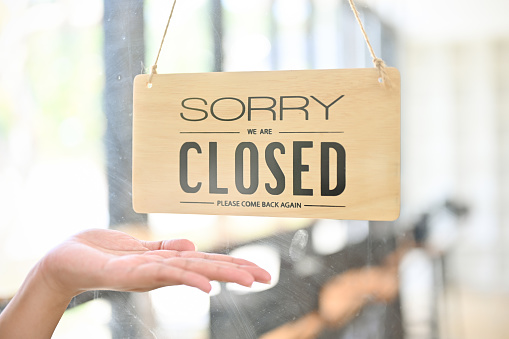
[0,264,73,339]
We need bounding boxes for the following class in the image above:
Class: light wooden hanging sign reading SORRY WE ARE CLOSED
[133,68,400,220]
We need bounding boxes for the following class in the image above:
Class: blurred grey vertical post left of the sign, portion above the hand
[104,0,147,228]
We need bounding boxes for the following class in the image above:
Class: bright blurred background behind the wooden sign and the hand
[0,0,509,339]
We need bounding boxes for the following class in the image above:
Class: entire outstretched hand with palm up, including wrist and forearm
[0,229,270,339]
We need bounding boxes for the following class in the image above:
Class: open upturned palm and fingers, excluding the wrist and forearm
[39,229,270,295]
